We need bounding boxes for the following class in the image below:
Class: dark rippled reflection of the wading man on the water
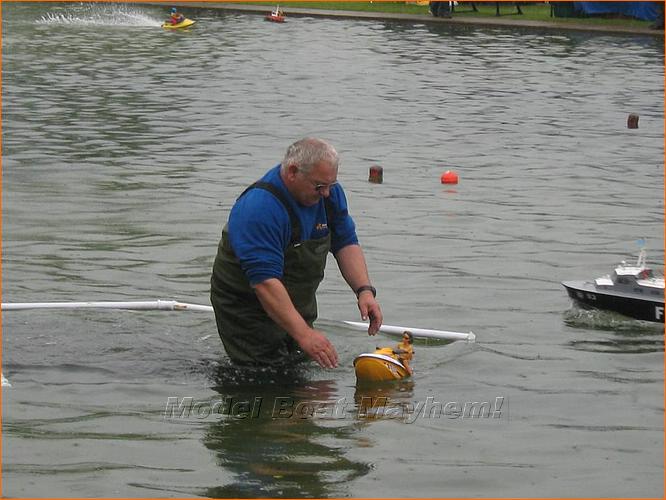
[203,367,372,498]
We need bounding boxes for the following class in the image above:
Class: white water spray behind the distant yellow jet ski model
[36,4,162,27]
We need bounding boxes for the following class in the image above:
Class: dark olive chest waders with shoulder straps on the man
[210,182,332,365]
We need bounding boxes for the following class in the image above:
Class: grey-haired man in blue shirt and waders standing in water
[210,137,382,368]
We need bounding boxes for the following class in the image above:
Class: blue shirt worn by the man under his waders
[228,165,358,285]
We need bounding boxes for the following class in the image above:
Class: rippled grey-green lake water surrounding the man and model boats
[2,3,664,498]
